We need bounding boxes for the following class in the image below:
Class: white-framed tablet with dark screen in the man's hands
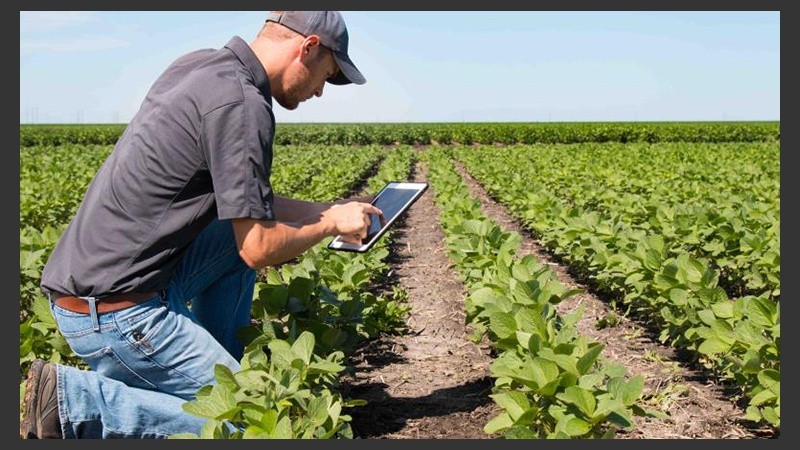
[328,181,428,253]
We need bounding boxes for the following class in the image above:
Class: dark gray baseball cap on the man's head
[267,11,367,84]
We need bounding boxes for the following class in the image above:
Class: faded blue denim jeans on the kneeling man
[50,220,256,438]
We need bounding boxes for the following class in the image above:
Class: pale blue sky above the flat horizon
[19,11,780,123]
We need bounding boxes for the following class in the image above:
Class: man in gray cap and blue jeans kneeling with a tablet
[20,11,382,438]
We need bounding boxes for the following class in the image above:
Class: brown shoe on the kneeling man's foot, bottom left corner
[19,359,63,439]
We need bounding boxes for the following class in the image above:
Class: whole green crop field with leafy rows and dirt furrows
[20,122,780,439]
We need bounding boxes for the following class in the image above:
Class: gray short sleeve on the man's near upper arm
[201,98,275,220]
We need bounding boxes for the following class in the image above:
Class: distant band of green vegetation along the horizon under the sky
[19,121,781,147]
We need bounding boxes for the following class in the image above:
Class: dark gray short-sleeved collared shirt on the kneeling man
[41,36,275,296]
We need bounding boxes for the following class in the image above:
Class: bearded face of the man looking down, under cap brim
[275,44,339,110]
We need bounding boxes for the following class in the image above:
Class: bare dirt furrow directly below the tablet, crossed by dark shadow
[342,163,497,439]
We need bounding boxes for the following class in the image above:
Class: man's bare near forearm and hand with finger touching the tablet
[232,202,383,269]
